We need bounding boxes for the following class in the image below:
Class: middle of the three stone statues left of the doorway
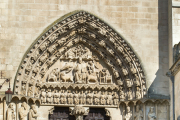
[19,102,29,120]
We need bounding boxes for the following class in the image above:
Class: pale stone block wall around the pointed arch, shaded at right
[0,0,169,97]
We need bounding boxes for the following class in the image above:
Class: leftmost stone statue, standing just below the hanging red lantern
[6,103,15,120]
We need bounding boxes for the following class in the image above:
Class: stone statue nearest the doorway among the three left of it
[29,105,38,120]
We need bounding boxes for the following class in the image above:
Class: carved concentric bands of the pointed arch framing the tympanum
[14,11,146,101]
